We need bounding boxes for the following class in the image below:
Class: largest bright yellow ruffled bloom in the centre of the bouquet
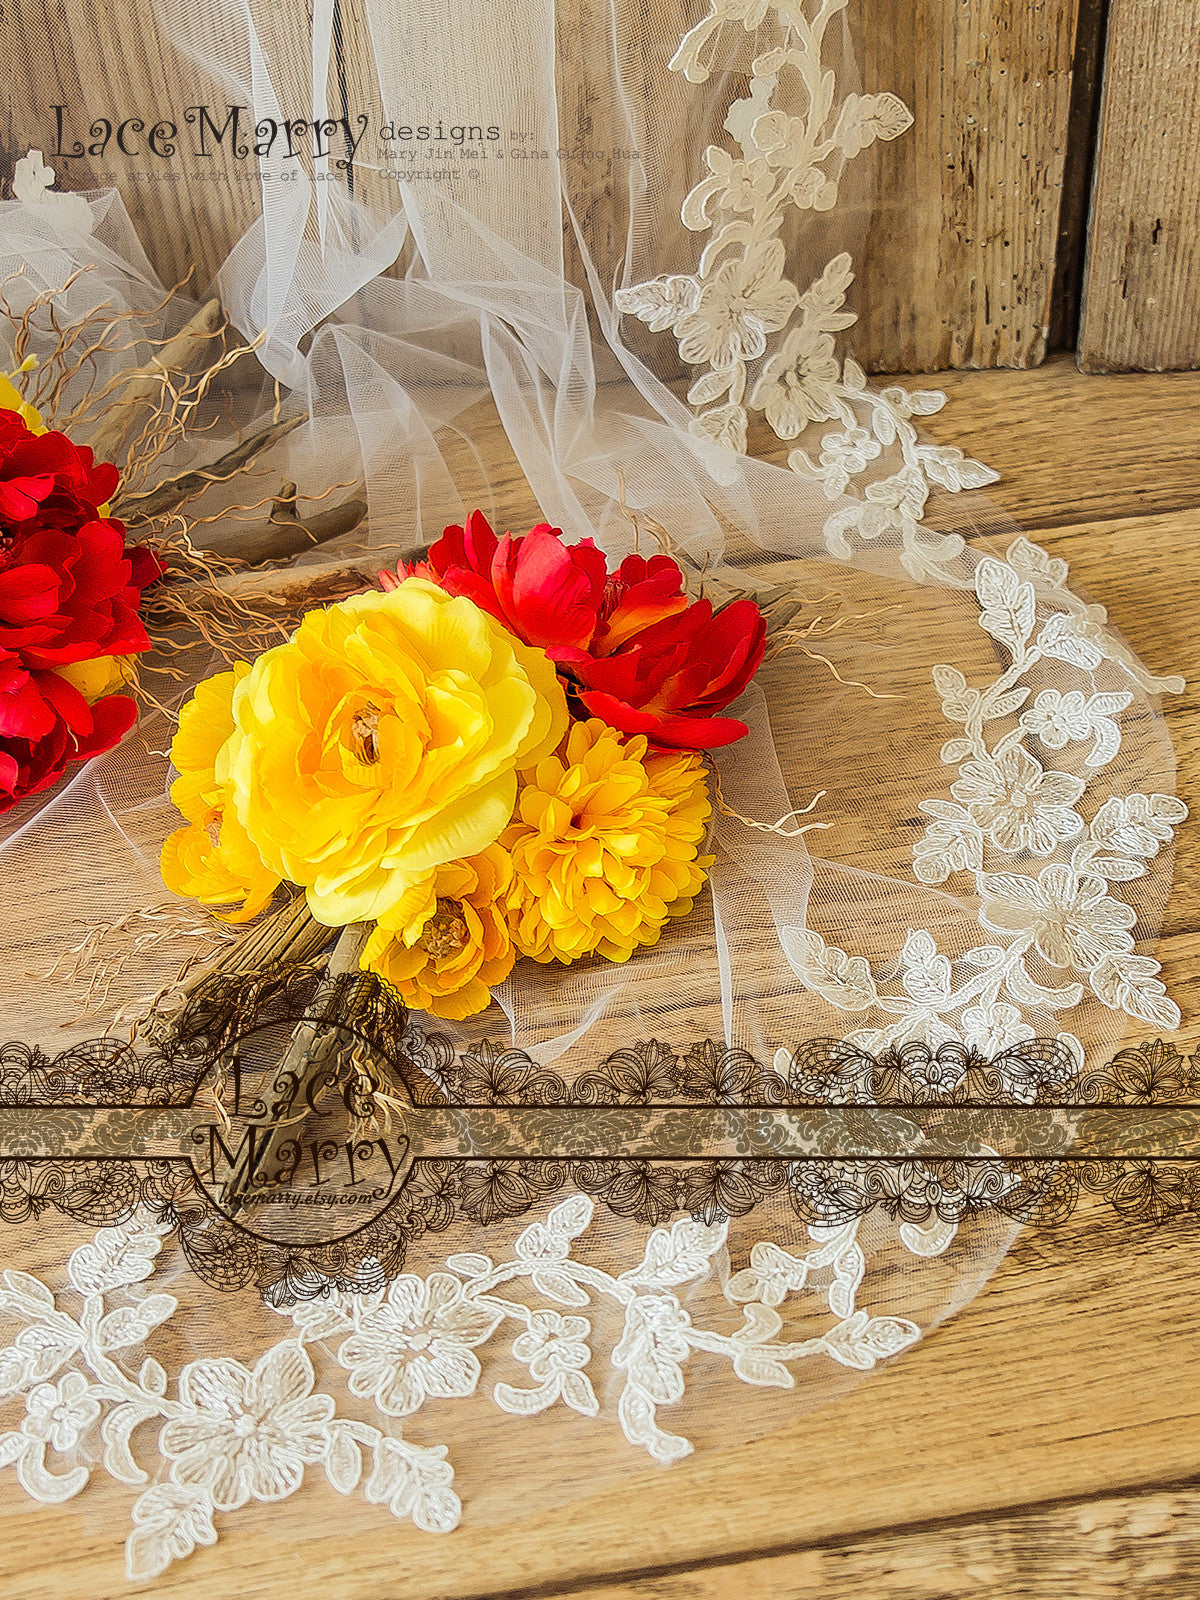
[229,578,568,928]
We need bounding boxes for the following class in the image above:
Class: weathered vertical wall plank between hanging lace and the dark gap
[853,0,1077,371]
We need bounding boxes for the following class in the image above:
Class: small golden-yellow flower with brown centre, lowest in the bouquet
[362,845,517,1021]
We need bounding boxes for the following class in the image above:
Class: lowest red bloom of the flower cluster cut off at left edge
[0,658,138,813]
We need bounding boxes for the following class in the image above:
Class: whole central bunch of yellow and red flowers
[162,512,766,1019]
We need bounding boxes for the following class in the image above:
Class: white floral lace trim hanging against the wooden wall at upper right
[614,0,997,579]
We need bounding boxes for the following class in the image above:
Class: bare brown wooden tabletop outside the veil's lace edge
[0,360,1200,1600]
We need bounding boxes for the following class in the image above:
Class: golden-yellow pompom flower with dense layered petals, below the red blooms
[501,718,712,962]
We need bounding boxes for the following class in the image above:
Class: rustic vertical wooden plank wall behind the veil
[0,0,1200,371]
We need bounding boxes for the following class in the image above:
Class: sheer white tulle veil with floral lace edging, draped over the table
[0,0,1186,1579]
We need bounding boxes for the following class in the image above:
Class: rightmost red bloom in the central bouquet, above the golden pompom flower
[571,600,766,750]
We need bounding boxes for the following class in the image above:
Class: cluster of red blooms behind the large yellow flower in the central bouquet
[390,512,766,750]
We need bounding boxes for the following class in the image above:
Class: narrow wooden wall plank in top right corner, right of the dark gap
[1078,0,1200,373]
